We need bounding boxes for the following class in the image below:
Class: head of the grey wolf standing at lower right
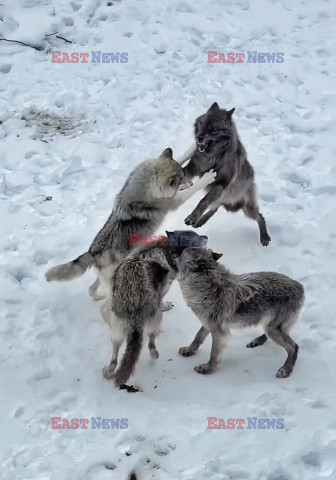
[178,247,223,274]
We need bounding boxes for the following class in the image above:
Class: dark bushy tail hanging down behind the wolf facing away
[114,328,143,387]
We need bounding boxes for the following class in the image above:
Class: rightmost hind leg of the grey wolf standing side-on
[265,318,299,378]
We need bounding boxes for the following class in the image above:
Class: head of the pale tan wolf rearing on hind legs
[152,148,192,198]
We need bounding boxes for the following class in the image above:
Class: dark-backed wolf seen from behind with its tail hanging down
[101,231,207,391]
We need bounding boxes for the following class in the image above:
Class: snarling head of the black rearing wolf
[194,103,237,155]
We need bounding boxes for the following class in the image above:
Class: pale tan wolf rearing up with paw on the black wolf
[46,148,214,300]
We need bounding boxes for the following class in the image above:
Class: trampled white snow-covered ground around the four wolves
[0,0,336,480]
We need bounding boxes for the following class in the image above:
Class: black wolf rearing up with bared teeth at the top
[179,103,271,246]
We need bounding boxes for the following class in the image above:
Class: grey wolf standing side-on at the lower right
[177,247,304,378]
